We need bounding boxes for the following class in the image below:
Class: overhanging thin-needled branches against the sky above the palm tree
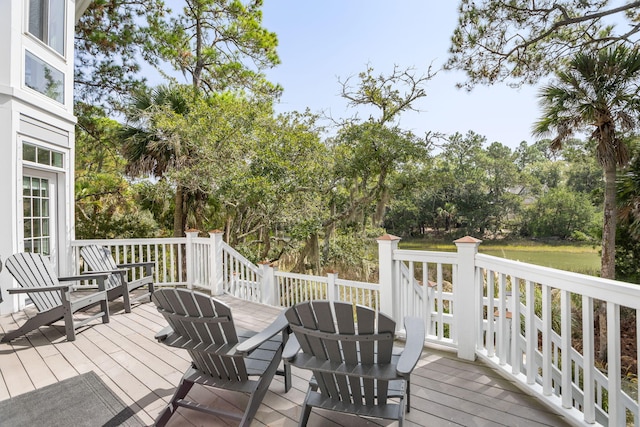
[446,0,640,87]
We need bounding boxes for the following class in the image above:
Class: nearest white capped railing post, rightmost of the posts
[453,236,482,360]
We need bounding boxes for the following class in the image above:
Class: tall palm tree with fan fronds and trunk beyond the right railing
[533,45,640,360]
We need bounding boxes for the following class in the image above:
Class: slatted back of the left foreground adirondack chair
[152,289,248,382]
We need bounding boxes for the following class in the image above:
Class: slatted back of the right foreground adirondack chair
[285,301,396,406]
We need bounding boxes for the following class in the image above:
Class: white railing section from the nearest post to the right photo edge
[476,254,640,426]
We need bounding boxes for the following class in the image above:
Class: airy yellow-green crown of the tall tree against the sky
[149,0,281,96]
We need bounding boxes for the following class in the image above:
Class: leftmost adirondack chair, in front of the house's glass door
[2,253,109,342]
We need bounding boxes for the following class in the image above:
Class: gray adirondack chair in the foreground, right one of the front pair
[283,301,425,426]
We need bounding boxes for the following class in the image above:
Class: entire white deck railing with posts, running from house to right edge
[72,232,640,426]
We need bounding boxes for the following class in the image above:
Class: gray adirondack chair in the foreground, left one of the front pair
[151,289,291,426]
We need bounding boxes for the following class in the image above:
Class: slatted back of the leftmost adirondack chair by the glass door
[5,252,62,313]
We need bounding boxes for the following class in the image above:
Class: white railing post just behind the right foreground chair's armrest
[378,234,404,328]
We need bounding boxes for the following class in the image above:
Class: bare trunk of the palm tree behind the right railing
[597,159,616,362]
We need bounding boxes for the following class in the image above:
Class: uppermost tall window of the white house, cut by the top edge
[29,0,65,55]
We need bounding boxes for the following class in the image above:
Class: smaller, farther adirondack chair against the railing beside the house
[80,245,155,313]
